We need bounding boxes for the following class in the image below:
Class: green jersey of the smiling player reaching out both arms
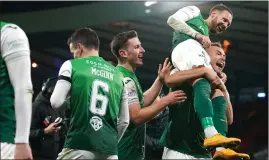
[117,66,145,160]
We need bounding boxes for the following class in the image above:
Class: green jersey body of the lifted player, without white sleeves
[172,14,209,49]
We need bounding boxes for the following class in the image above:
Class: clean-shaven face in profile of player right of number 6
[126,37,145,67]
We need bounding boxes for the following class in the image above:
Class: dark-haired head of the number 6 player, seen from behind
[67,28,100,58]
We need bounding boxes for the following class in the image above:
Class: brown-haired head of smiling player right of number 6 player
[110,30,145,67]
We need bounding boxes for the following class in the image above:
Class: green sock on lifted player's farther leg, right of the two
[212,96,228,136]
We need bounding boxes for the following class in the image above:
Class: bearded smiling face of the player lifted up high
[210,10,230,34]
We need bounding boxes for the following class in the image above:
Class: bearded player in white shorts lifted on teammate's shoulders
[167,4,241,148]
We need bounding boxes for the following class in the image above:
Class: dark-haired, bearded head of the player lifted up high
[208,4,233,34]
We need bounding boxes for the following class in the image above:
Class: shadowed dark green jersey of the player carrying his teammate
[161,83,211,158]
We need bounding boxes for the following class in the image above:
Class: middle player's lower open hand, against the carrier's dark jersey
[162,90,187,105]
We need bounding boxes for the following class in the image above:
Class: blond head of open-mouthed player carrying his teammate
[206,42,226,73]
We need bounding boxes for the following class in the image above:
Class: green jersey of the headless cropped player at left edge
[0,22,16,143]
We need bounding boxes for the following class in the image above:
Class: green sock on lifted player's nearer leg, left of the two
[193,79,213,129]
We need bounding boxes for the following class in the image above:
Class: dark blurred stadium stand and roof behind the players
[0,1,268,159]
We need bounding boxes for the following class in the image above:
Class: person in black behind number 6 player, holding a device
[30,78,68,160]
